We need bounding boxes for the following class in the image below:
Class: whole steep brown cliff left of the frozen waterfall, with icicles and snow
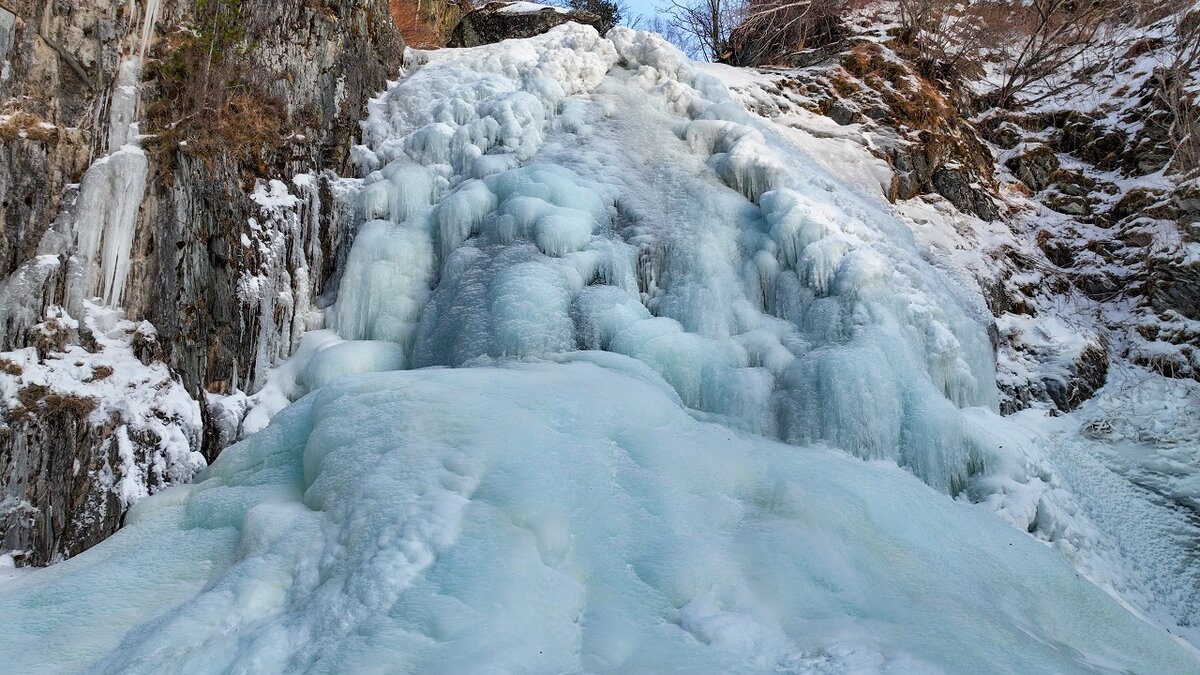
[0,0,403,565]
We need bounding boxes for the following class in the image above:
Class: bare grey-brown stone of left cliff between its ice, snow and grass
[0,0,404,565]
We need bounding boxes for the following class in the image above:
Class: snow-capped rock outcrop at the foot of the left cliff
[0,303,206,565]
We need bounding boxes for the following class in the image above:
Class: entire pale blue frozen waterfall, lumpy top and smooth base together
[0,24,1200,673]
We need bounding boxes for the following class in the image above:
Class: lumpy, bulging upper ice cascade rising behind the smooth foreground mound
[332,25,995,492]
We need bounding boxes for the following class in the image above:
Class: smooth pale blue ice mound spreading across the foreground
[0,365,1196,673]
